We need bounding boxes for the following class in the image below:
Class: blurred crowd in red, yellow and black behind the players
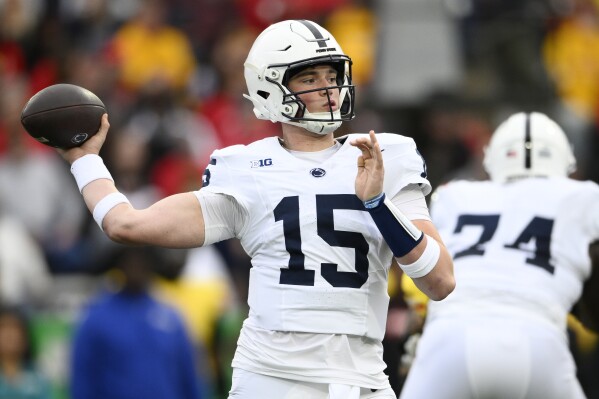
[0,0,599,399]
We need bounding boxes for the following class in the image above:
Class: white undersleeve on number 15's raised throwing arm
[194,190,246,245]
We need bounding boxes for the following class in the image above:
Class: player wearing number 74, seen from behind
[400,112,599,399]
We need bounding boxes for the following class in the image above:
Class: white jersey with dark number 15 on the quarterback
[201,133,430,388]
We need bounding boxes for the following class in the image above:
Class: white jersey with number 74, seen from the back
[429,178,599,331]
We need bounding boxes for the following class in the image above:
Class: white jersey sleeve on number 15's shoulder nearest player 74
[377,133,432,197]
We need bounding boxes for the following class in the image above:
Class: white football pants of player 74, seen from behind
[399,318,585,399]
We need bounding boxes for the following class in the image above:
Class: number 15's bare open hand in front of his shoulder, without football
[350,130,385,201]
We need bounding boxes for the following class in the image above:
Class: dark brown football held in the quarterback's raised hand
[21,83,106,149]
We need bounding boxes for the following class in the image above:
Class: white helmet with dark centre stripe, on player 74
[483,112,576,182]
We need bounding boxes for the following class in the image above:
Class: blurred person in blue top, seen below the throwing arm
[70,247,202,399]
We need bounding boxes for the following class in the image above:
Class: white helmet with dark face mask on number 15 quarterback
[243,20,355,135]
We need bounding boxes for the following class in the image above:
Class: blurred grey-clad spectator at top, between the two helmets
[373,0,464,107]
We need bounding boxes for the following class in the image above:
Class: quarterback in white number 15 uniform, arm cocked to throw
[54,20,455,399]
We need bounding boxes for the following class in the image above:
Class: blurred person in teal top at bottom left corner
[0,307,52,399]
